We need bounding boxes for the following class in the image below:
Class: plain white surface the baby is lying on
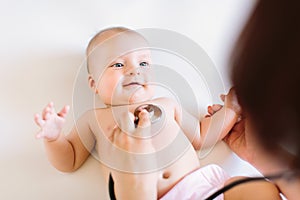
[0,0,255,200]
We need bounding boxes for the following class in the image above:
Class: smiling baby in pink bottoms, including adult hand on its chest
[35,27,278,199]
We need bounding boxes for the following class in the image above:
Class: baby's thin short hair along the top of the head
[86,26,132,73]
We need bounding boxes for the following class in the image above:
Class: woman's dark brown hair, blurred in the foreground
[231,0,300,168]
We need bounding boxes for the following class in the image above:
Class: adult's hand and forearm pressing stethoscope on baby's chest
[110,110,158,200]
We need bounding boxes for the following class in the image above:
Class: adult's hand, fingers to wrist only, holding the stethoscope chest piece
[106,110,157,173]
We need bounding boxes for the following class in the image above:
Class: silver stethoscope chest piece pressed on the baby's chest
[133,104,162,126]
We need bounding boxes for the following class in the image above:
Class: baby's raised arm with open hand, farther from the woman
[35,103,94,172]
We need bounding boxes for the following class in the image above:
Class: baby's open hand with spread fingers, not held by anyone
[34,102,69,141]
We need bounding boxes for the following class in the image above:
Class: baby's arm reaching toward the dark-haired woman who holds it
[175,89,241,150]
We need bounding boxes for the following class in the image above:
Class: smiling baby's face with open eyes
[91,30,153,105]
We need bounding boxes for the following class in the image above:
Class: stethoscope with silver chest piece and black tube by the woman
[134,104,299,200]
